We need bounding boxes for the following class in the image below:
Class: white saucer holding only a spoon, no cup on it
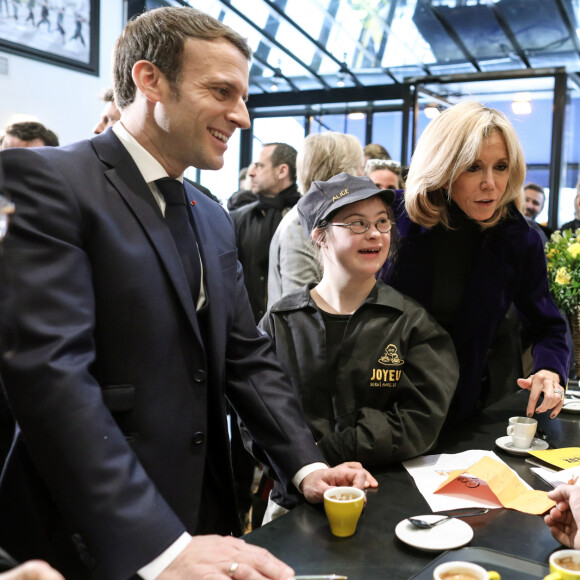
[395,514,473,552]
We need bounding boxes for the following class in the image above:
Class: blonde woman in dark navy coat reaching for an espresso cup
[380,102,569,421]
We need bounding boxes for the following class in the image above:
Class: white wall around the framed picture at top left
[0,0,123,145]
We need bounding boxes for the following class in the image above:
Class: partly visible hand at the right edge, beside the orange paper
[544,485,580,549]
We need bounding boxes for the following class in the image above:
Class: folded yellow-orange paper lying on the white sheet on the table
[435,457,556,515]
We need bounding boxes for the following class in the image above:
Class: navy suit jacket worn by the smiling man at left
[0,131,323,580]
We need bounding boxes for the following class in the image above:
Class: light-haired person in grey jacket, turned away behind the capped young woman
[268,132,364,308]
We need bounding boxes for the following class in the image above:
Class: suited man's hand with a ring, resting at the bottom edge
[158,536,294,580]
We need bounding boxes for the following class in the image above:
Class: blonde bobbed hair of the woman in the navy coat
[405,101,526,228]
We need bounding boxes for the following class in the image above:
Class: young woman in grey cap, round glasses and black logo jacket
[260,173,459,521]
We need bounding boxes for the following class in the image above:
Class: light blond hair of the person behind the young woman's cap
[296,131,363,195]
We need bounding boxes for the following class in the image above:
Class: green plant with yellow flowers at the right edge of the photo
[546,229,580,315]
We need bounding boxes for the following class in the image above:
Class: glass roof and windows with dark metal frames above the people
[179,0,580,223]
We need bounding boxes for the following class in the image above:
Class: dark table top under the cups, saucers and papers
[244,391,580,580]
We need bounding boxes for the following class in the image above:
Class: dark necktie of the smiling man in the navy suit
[155,177,201,304]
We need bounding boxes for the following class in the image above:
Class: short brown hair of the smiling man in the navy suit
[113,6,252,109]
